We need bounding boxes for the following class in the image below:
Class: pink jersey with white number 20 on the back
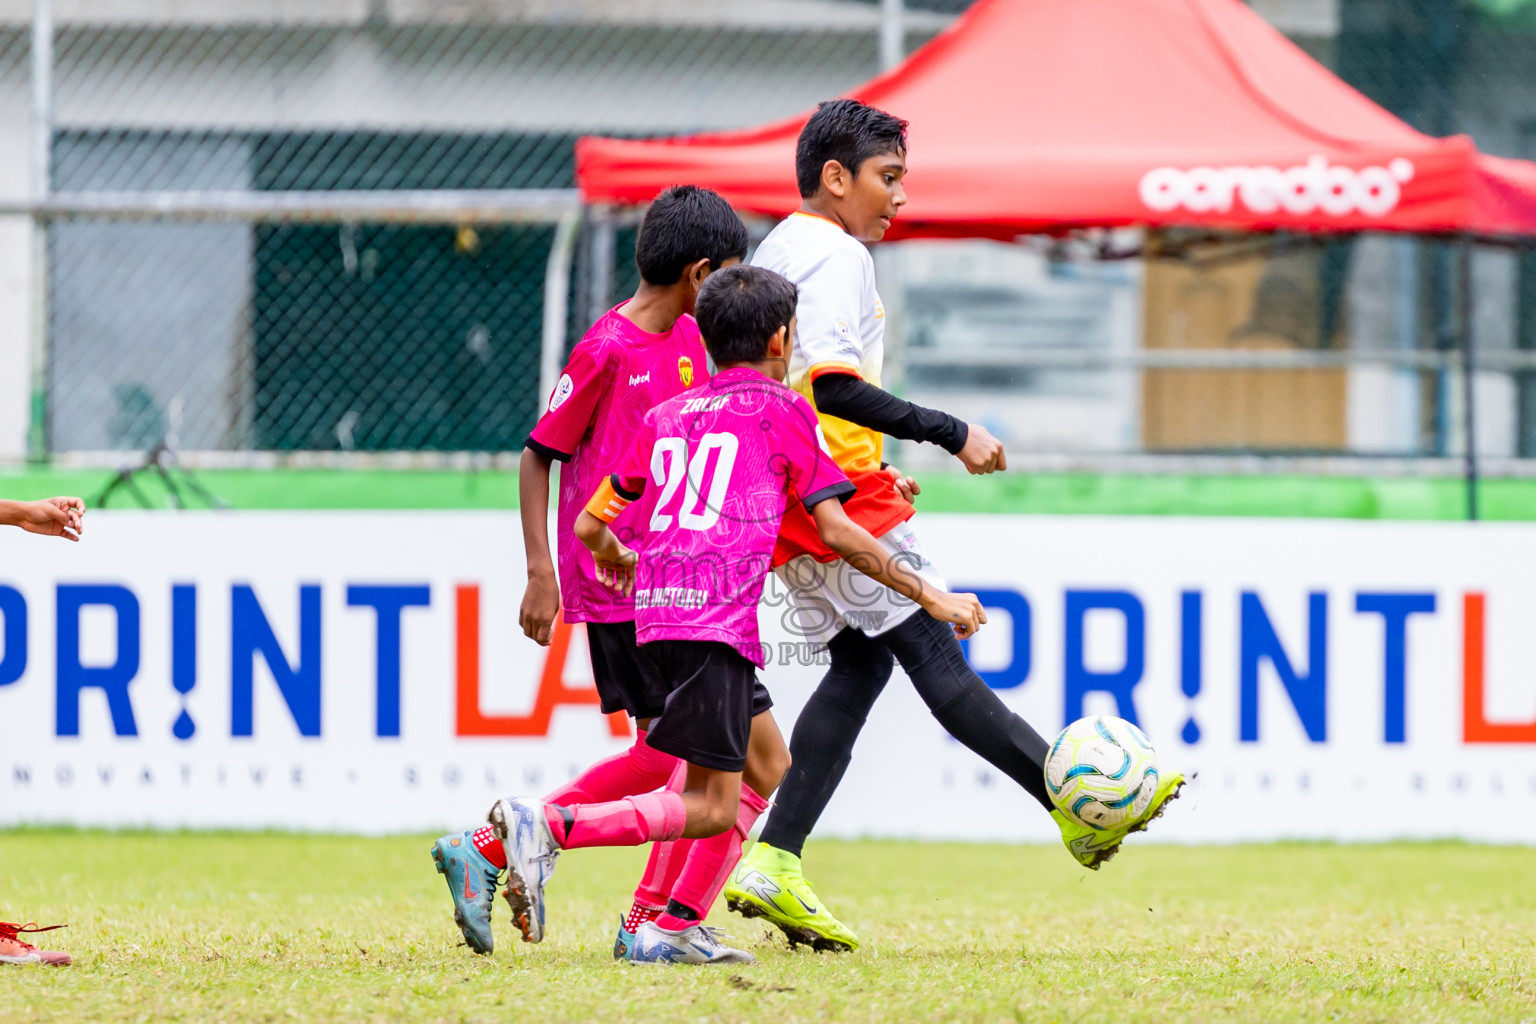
[613,367,854,666]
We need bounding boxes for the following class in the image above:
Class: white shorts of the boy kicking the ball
[774,520,948,643]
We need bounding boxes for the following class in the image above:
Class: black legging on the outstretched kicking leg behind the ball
[882,611,1055,811]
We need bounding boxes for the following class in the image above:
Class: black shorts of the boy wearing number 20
[639,640,773,772]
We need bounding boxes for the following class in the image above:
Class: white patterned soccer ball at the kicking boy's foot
[1046,715,1158,831]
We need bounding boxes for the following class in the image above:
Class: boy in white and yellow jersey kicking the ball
[725,100,1183,950]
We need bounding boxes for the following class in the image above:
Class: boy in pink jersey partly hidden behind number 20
[432,186,748,953]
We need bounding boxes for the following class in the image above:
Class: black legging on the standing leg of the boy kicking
[760,629,894,857]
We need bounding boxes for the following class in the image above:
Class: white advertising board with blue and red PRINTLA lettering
[0,511,1536,841]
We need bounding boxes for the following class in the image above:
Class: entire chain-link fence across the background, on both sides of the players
[0,0,1536,465]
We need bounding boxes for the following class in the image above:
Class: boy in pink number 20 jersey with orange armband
[490,267,986,964]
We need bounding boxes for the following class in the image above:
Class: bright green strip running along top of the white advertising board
[0,467,1536,520]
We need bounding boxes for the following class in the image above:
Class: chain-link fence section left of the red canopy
[0,0,955,453]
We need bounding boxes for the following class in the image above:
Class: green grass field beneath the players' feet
[0,831,1536,1024]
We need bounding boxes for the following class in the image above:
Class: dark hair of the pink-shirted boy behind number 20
[634,184,746,286]
